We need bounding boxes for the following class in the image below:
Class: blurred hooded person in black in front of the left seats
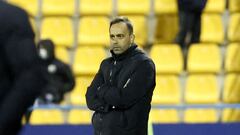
[37,39,75,104]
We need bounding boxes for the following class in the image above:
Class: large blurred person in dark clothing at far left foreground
[0,0,48,135]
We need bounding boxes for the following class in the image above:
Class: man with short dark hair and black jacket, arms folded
[86,17,155,135]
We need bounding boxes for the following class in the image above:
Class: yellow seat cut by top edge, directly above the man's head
[117,0,150,15]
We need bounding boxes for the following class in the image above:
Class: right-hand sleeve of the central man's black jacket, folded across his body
[99,61,155,109]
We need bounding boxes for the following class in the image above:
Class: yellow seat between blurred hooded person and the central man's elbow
[70,76,93,105]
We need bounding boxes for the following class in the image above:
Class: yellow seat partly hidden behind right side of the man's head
[124,16,148,46]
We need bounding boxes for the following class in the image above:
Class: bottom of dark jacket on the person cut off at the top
[177,0,207,12]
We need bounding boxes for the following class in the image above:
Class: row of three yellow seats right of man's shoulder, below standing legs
[149,43,240,74]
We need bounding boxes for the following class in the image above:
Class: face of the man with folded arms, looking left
[110,22,134,54]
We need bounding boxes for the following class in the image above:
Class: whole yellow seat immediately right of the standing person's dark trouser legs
[200,13,224,44]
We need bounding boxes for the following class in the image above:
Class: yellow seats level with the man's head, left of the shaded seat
[32,16,148,47]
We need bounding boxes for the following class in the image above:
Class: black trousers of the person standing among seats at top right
[176,11,201,49]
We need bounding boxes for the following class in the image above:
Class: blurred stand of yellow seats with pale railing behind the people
[6,0,240,135]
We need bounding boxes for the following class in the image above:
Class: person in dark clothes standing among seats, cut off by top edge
[176,0,207,50]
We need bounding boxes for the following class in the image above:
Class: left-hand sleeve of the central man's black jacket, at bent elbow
[85,62,109,112]
